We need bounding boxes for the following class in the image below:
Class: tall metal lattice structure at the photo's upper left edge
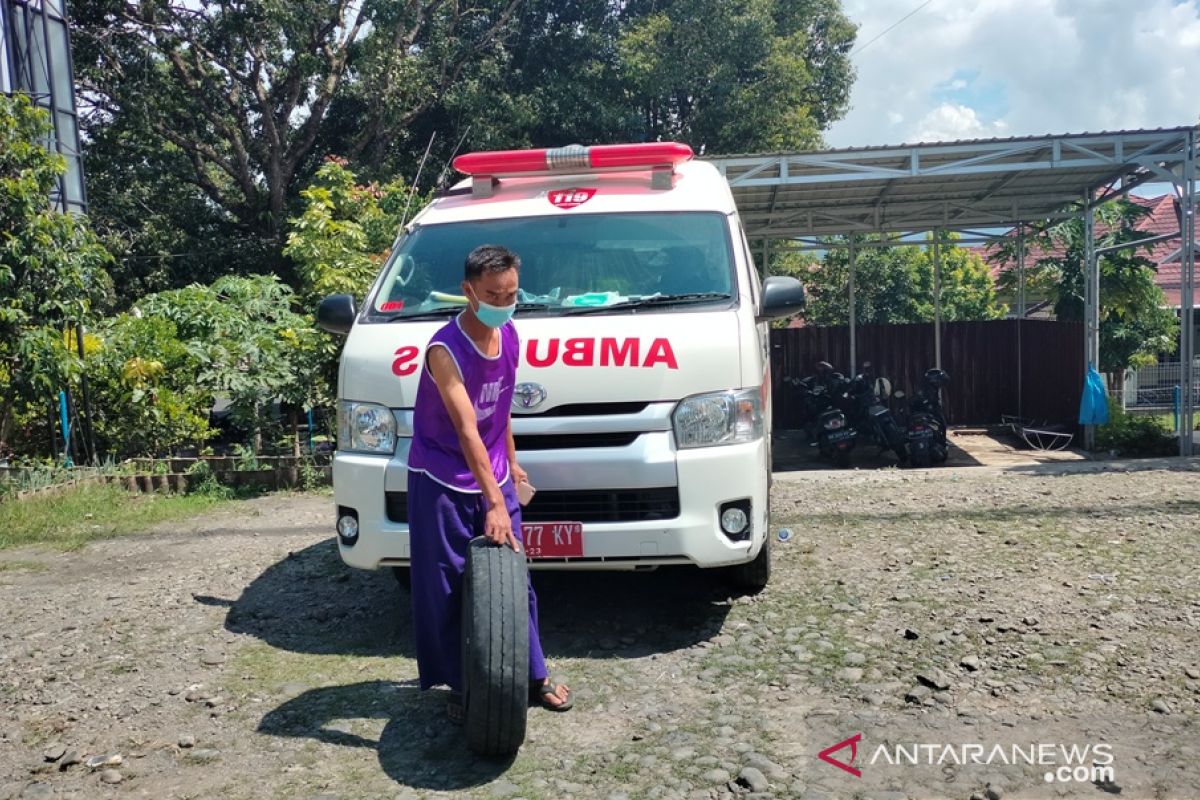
[0,0,88,213]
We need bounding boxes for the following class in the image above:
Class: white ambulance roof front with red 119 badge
[413,161,737,225]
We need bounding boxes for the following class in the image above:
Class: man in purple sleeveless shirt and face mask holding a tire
[408,245,571,723]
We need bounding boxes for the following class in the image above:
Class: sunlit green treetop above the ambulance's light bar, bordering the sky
[618,0,854,152]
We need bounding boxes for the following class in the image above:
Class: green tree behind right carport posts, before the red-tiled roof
[992,200,1180,374]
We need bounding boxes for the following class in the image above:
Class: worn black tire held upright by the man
[462,537,529,757]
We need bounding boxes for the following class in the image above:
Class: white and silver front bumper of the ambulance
[334,431,769,570]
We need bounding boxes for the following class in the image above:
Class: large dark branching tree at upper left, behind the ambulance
[72,0,518,283]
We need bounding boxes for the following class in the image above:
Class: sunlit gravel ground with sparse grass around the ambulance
[0,459,1200,800]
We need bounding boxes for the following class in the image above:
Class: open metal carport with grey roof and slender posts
[706,127,1196,456]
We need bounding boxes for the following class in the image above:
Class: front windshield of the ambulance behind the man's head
[367,211,734,321]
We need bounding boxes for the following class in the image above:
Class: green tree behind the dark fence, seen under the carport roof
[792,234,1007,325]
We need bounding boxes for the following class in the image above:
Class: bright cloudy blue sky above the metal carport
[826,0,1200,148]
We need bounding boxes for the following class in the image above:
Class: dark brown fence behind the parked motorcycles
[770,319,1084,428]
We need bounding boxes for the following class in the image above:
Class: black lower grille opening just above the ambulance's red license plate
[384,486,679,523]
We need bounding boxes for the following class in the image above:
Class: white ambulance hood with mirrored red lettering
[340,308,742,413]
